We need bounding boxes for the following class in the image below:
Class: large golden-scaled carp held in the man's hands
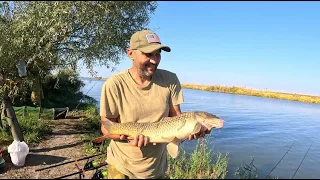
[101,111,224,158]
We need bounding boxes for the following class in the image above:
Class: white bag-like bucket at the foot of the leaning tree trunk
[8,140,29,167]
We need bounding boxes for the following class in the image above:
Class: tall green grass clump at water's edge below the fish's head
[168,140,228,179]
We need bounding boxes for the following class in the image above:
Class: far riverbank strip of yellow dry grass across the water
[182,84,320,104]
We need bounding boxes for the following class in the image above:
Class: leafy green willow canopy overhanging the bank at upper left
[0,1,157,141]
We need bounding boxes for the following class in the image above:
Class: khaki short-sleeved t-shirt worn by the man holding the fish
[100,69,184,178]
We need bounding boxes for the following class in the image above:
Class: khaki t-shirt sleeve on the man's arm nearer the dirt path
[100,78,119,118]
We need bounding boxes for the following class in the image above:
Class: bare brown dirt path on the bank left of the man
[0,116,107,179]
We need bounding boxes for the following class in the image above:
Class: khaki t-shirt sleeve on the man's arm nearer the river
[170,74,184,106]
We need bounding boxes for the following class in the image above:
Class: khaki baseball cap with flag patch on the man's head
[130,30,171,53]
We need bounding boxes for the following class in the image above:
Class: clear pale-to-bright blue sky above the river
[80,1,320,95]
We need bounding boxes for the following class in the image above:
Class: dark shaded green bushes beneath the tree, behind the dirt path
[13,70,97,110]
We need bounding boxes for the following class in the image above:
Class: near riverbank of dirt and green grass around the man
[0,105,229,179]
